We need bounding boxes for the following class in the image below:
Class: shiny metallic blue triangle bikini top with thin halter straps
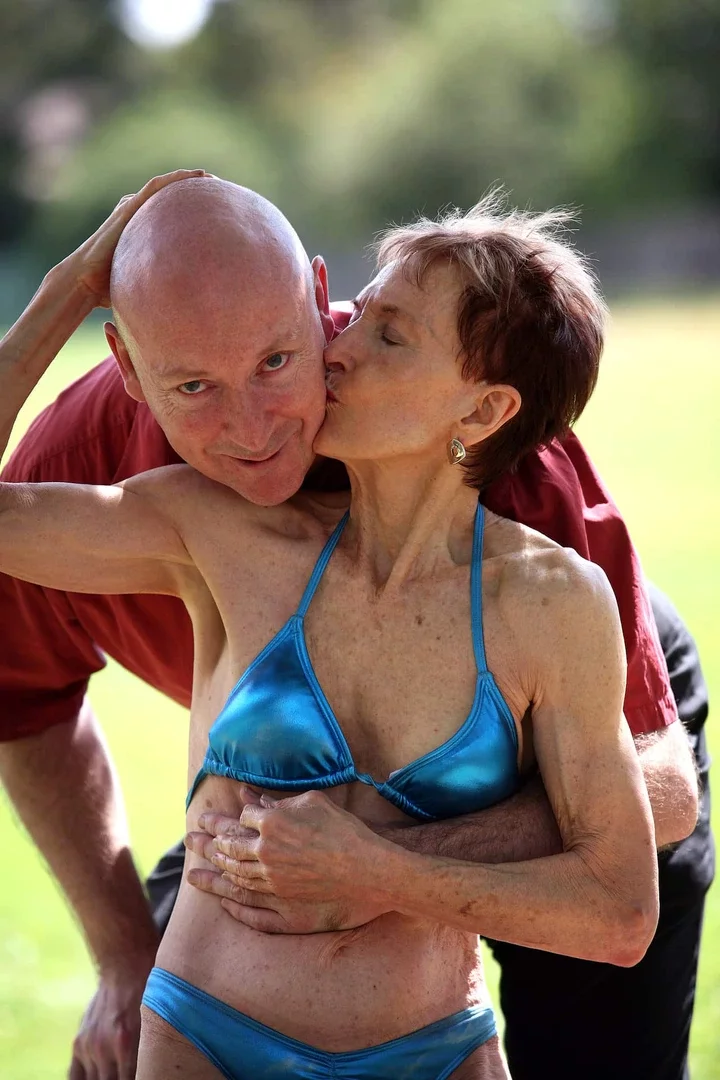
[187,502,519,821]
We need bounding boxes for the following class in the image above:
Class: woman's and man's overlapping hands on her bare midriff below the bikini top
[186,785,392,932]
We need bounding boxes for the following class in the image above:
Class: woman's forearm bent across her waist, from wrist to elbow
[381,845,657,967]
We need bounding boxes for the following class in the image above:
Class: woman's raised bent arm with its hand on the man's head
[0,171,208,593]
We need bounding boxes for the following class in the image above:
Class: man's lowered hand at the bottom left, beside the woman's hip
[68,953,154,1080]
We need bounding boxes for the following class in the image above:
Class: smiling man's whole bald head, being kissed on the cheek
[105,177,334,504]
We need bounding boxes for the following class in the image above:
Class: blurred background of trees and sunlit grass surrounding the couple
[0,0,720,1080]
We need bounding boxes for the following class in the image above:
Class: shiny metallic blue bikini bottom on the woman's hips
[142,968,495,1080]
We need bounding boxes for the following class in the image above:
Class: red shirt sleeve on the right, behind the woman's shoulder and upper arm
[485,434,678,735]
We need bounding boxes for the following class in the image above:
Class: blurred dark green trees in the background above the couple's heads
[0,0,720,265]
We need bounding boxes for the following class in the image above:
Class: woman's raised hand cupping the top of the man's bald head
[62,168,209,308]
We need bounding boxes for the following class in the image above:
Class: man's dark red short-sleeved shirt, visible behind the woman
[0,315,677,740]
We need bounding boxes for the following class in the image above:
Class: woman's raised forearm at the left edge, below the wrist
[0,261,95,456]
